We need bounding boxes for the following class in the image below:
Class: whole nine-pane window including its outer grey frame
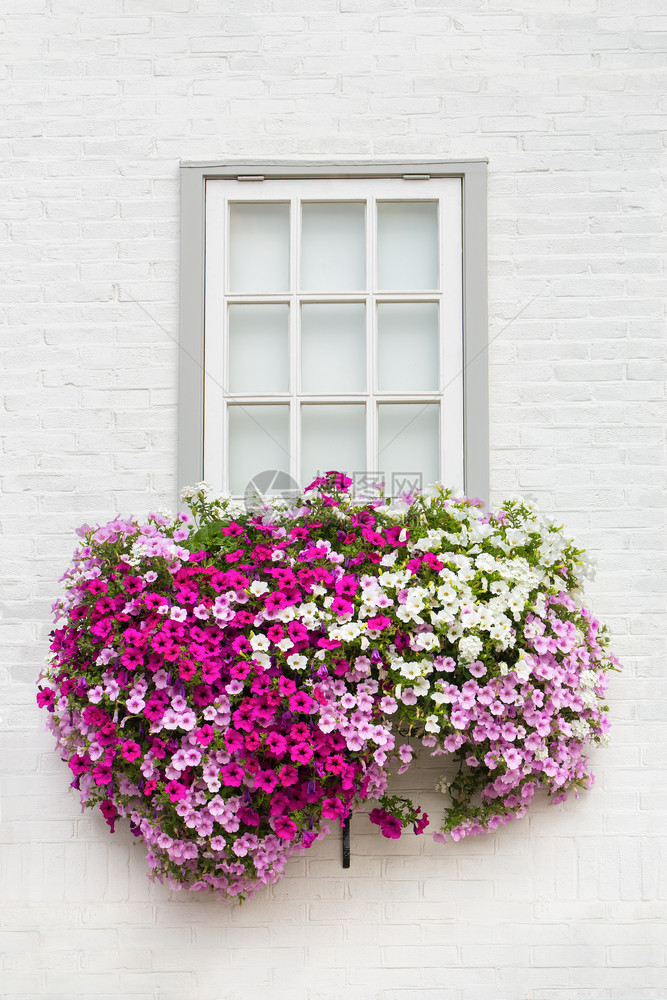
[179,162,488,504]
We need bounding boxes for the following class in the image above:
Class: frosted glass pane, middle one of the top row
[301,202,366,292]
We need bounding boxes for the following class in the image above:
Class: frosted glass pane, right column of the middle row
[378,302,439,392]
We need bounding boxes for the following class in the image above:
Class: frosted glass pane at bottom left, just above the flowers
[228,405,289,496]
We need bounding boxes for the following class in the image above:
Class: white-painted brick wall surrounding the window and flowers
[0,0,667,1000]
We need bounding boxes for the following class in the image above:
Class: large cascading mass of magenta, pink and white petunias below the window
[37,473,618,898]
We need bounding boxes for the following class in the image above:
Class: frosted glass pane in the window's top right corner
[377,201,438,292]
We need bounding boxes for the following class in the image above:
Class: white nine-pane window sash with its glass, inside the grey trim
[204,177,463,495]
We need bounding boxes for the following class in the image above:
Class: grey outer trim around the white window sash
[178,160,489,500]
